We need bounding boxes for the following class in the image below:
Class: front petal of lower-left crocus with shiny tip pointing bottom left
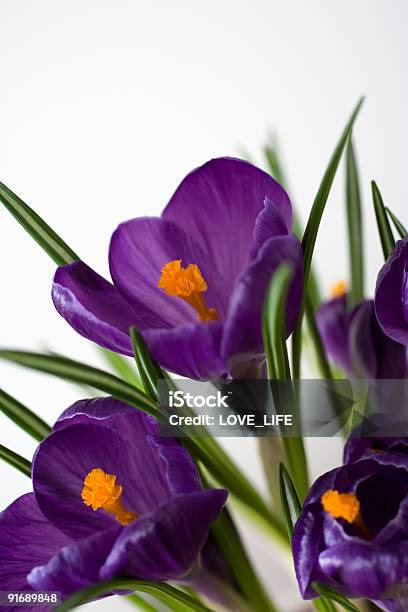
[27,525,121,599]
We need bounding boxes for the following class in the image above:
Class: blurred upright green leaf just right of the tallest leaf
[346,136,364,308]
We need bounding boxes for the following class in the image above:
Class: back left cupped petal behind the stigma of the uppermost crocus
[109,217,228,330]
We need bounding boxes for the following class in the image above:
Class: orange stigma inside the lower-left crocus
[81,468,137,525]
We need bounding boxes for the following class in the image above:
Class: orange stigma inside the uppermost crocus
[157,259,218,321]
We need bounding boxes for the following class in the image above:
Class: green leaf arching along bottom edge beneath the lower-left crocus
[56,578,211,612]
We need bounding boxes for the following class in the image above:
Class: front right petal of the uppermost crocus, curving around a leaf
[221,235,303,363]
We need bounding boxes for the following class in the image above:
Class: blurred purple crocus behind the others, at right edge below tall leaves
[316,293,407,379]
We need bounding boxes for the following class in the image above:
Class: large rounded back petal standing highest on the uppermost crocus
[162,158,292,302]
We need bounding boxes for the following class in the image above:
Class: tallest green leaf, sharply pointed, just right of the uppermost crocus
[292,98,363,379]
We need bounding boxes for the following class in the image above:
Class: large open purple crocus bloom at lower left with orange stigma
[0,398,227,610]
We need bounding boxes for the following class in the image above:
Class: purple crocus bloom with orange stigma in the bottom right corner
[292,450,408,612]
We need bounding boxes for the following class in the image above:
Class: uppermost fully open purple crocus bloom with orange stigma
[52,158,303,379]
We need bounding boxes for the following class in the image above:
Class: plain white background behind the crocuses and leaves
[0,0,408,610]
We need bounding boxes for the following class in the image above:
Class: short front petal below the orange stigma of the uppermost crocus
[143,321,228,380]
